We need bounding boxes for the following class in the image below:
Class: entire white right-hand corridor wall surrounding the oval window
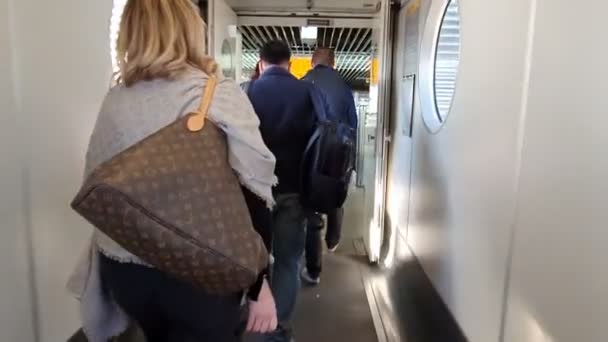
[408,0,608,342]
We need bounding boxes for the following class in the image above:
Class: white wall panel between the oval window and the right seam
[408,0,530,342]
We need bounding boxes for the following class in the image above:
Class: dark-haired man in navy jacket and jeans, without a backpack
[247,41,317,342]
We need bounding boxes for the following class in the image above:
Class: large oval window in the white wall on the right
[420,0,460,132]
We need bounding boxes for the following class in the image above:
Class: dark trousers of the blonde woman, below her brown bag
[100,255,244,342]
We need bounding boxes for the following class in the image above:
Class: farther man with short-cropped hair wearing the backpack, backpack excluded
[302,47,357,285]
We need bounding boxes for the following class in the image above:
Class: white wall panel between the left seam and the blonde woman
[8,0,112,342]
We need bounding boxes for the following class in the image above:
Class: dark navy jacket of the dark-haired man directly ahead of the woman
[247,67,317,194]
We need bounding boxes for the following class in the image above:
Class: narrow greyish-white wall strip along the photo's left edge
[0,0,34,342]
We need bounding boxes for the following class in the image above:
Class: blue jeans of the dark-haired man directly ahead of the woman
[266,194,306,342]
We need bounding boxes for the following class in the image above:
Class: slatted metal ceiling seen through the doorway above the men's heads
[239,26,372,88]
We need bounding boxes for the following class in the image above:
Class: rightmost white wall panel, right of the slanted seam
[504,0,608,342]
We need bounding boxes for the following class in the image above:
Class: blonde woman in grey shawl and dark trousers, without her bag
[69,0,277,342]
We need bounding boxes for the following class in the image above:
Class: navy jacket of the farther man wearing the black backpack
[303,65,357,129]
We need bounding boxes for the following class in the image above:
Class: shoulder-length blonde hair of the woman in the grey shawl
[116,0,218,86]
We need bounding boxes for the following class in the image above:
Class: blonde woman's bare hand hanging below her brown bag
[247,280,278,334]
